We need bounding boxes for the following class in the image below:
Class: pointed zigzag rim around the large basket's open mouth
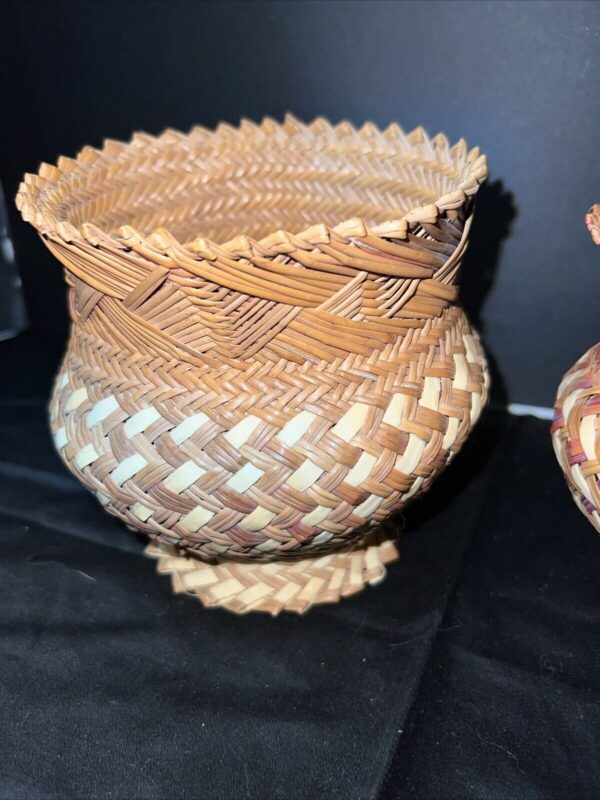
[15,113,488,259]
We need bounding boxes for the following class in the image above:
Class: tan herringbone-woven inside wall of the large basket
[43,120,472,243]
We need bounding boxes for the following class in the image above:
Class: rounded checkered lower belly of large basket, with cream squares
[51,292,485,559]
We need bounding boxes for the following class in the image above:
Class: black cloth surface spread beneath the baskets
[0,334,600,800]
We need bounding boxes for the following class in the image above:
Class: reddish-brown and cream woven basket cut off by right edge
[551,205,600,533]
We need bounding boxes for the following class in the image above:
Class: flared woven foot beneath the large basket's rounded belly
[145,537,399,616]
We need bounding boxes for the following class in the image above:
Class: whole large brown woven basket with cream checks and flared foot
[17,117,488,613]
